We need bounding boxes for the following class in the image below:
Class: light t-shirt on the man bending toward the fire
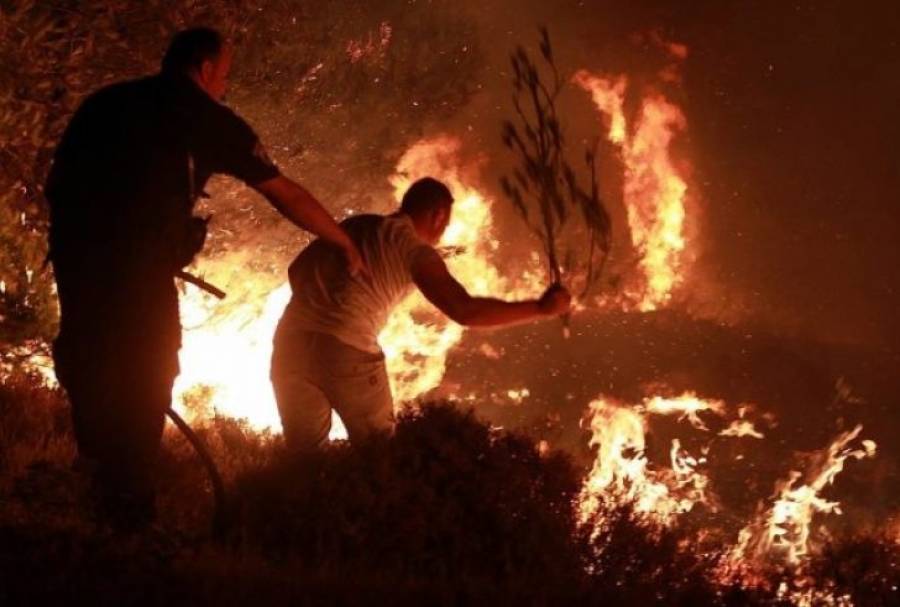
[278,214,437,352]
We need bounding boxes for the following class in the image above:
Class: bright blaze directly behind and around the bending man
[173,137,542,430]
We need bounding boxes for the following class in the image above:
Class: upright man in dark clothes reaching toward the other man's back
[46,28,362,522]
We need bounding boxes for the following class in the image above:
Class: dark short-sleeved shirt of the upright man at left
[46,74,279,261]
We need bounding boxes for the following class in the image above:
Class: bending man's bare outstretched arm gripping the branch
[412,251,571,327]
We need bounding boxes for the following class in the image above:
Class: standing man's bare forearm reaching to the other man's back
[253,175,366,276]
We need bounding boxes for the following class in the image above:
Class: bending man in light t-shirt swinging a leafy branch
[271,178,571,453]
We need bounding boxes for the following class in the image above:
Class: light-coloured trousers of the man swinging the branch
[271,330,394,453]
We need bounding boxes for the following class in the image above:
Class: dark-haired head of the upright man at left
[162,27,232,100]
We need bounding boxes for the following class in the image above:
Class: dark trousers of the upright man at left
[53,257,181,519]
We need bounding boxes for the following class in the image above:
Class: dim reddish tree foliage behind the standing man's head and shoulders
[0,0,478,356]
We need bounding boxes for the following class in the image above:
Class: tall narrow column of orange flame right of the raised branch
[575,71,688,311]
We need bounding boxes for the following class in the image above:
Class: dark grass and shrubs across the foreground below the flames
[0,368,900,605]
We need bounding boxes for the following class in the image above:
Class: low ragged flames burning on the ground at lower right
[578,393,876,606]
